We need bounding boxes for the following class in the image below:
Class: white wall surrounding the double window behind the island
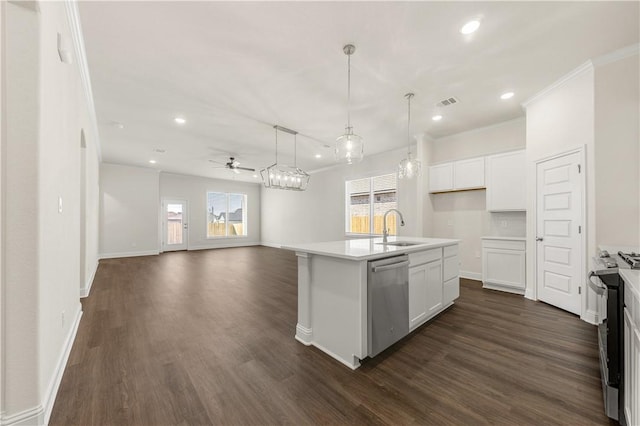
[261,146,422,246]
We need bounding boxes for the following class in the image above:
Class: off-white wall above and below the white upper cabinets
[423,118,526,279]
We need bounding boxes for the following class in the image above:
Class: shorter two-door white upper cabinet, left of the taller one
[429,157,485,192]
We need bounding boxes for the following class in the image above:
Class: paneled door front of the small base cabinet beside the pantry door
[482,247,526,290]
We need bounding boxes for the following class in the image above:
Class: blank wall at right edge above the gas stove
[595,49,640,248]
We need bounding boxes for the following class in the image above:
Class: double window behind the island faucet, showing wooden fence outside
[346,173,398,235]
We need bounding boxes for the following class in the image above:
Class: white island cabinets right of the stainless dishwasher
[409,246,460,330]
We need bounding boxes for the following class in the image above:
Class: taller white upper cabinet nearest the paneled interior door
[486,150,527,212]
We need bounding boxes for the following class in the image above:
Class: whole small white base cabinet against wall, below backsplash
[482,237,526,294]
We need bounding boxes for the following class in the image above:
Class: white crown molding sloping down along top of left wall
[64,0,102,161]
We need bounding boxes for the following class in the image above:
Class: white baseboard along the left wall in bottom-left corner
[0,304,82,426]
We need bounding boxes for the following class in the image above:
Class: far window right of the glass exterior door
[207,192,247,238]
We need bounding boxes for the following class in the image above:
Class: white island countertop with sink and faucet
[282,237,460,260]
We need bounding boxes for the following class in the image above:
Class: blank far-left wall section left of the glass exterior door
[99,163,160,258]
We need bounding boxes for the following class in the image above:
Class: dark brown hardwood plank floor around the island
[50,247,609,425]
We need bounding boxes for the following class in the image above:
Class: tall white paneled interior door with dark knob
[536,152,584,315]
